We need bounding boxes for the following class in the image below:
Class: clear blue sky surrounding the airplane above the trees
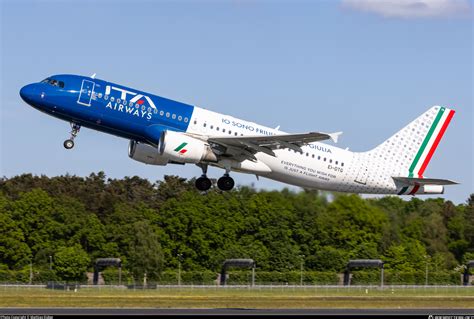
[0,0,474,203]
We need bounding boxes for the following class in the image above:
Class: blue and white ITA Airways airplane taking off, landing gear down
[20,74,457,195]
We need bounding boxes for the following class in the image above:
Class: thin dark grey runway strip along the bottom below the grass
[0,308,474,316]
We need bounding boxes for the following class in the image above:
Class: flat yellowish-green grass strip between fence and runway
[0,286,474,309]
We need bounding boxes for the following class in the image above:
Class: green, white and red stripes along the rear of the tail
[398,107,455,195]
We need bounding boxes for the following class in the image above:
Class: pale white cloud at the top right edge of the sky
[342,0,471,18]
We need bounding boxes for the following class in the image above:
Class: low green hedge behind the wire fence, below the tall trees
[0,269,474,286]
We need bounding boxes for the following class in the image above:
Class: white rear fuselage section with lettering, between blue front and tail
[187,107,397,194]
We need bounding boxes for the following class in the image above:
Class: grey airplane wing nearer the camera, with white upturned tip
[203,132,342,160]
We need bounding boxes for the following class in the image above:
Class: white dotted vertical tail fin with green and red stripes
[367,106,455,193]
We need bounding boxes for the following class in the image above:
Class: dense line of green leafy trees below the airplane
[0,172,474,281]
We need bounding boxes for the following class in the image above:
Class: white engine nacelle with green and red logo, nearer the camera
[159,131,217,163]
